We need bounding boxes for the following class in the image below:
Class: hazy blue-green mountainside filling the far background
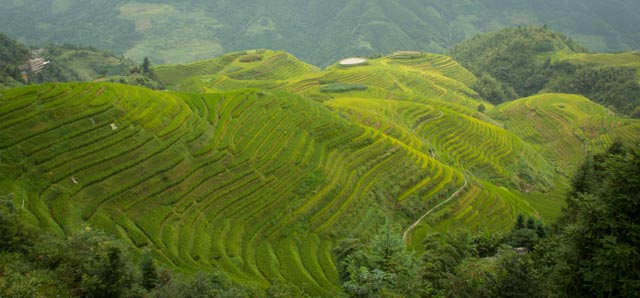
[0,0,640,66]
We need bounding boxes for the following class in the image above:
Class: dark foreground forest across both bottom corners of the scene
[0,142,640,297]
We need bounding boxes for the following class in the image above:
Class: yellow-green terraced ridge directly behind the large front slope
[326,98,553,190]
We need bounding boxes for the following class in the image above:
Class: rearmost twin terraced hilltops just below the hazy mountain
[155,50,488,113]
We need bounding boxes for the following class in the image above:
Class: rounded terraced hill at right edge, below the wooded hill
[490,93,640,175]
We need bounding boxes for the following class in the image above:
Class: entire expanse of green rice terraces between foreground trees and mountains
[5,50,640,296]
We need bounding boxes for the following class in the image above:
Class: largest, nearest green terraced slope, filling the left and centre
[0,84,476,296]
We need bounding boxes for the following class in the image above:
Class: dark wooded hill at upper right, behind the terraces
[450,27,640,115]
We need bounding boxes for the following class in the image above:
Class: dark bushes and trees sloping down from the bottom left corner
[0,197,251,297]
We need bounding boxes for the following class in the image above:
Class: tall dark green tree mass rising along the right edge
[549,142,640,297]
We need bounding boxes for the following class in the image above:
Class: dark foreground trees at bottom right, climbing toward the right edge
[339,143,640,297]
